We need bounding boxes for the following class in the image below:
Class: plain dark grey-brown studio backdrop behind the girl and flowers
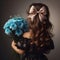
[0,0,60,60]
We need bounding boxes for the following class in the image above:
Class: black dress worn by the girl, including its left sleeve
[17,37,53,60]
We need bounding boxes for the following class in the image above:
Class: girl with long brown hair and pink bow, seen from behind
[11,3,54,60]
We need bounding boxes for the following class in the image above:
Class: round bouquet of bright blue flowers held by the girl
[3,17,29,40]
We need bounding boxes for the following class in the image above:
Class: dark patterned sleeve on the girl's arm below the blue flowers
[16,37,29,50]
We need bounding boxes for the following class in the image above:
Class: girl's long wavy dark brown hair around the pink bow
[27,3,53,46]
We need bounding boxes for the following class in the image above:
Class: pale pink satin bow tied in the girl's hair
[28,6,47,21]
